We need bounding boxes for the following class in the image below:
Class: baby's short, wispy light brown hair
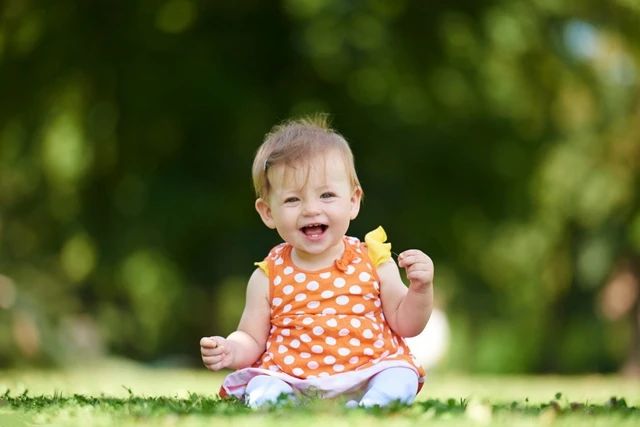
[252,113,360,199]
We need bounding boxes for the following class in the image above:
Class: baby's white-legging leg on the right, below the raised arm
[359,368,418,408]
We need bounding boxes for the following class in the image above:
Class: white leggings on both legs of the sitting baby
[245,368,418,408]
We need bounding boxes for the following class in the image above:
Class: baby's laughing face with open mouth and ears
[256,151,362,261]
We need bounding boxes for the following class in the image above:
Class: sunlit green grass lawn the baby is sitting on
[0,361,640,427]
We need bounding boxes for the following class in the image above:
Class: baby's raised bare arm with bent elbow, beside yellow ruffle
[378,249,434,337]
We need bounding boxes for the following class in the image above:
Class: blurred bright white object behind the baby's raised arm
[405,308,450,369]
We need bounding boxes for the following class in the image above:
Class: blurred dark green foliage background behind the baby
[0,0,640,373]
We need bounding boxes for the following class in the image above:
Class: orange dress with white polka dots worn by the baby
[221,231,425,398]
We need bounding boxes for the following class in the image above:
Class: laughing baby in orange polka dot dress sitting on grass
[200,116,434,407]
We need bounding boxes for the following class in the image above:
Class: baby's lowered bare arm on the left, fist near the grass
[200,269,271,371]
